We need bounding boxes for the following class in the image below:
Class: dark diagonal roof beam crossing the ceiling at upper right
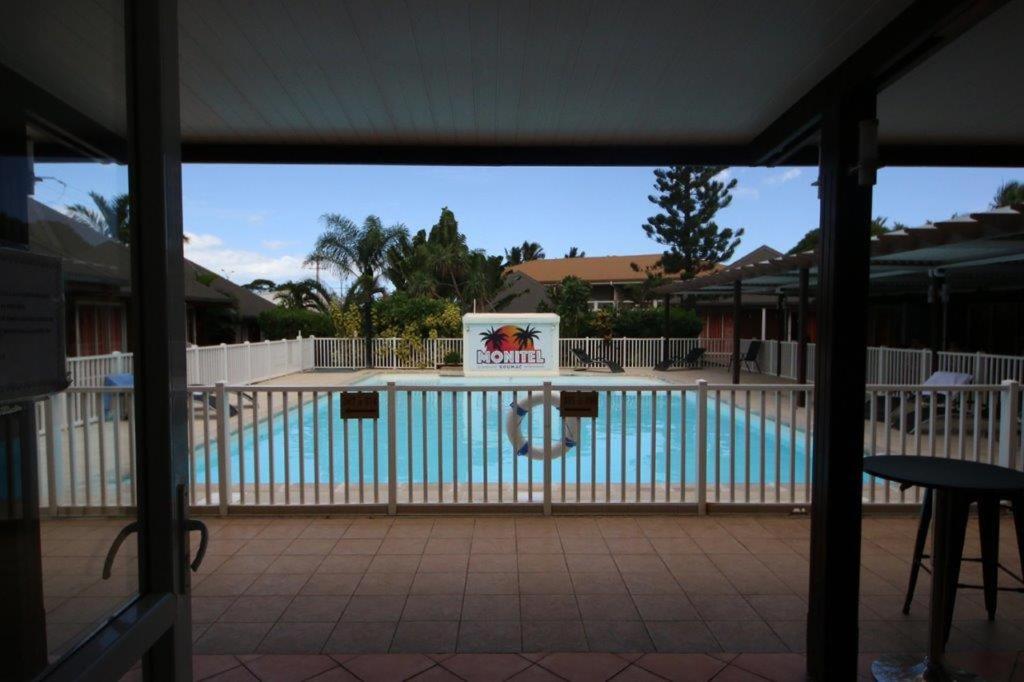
[751,0,1008,166]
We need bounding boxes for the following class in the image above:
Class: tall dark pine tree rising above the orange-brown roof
[643,166,743,280]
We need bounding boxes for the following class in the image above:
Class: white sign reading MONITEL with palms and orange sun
[462,312,558,376]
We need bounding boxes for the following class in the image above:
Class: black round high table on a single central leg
[864,455,1024,680]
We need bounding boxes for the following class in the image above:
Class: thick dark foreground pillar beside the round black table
[807,91,874,680]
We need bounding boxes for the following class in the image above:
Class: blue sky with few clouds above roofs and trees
[37,164,1024,294]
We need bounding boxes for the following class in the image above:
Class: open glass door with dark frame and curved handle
[0,0,195,680]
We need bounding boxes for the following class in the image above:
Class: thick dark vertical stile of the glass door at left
[126,0,191,680]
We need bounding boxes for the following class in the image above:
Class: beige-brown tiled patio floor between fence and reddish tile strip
[44,515,1024,655]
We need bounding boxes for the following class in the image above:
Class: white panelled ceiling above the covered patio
[0,0,1024,156]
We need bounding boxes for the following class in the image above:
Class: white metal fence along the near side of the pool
[38,374,1022,513]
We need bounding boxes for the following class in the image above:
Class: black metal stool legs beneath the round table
[900,485,1024,621]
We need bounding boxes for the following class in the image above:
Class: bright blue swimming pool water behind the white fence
[195,373,809,485]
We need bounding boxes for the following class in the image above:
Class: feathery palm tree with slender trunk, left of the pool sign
[306,213,409,367]
